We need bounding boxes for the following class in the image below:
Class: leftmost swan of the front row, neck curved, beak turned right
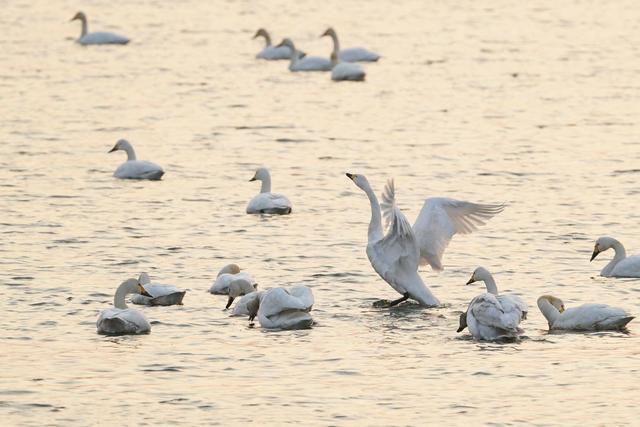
[96,279,151,335]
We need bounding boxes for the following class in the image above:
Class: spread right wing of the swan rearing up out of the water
[413,197,504,271]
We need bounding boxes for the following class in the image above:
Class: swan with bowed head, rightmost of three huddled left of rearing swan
[247,286,314,329]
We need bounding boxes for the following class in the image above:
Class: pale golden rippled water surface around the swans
[0,0,640,426]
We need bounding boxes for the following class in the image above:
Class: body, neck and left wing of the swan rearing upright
[346,173,440,307]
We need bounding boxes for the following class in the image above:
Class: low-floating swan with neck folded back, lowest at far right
[538,295,634,331]
